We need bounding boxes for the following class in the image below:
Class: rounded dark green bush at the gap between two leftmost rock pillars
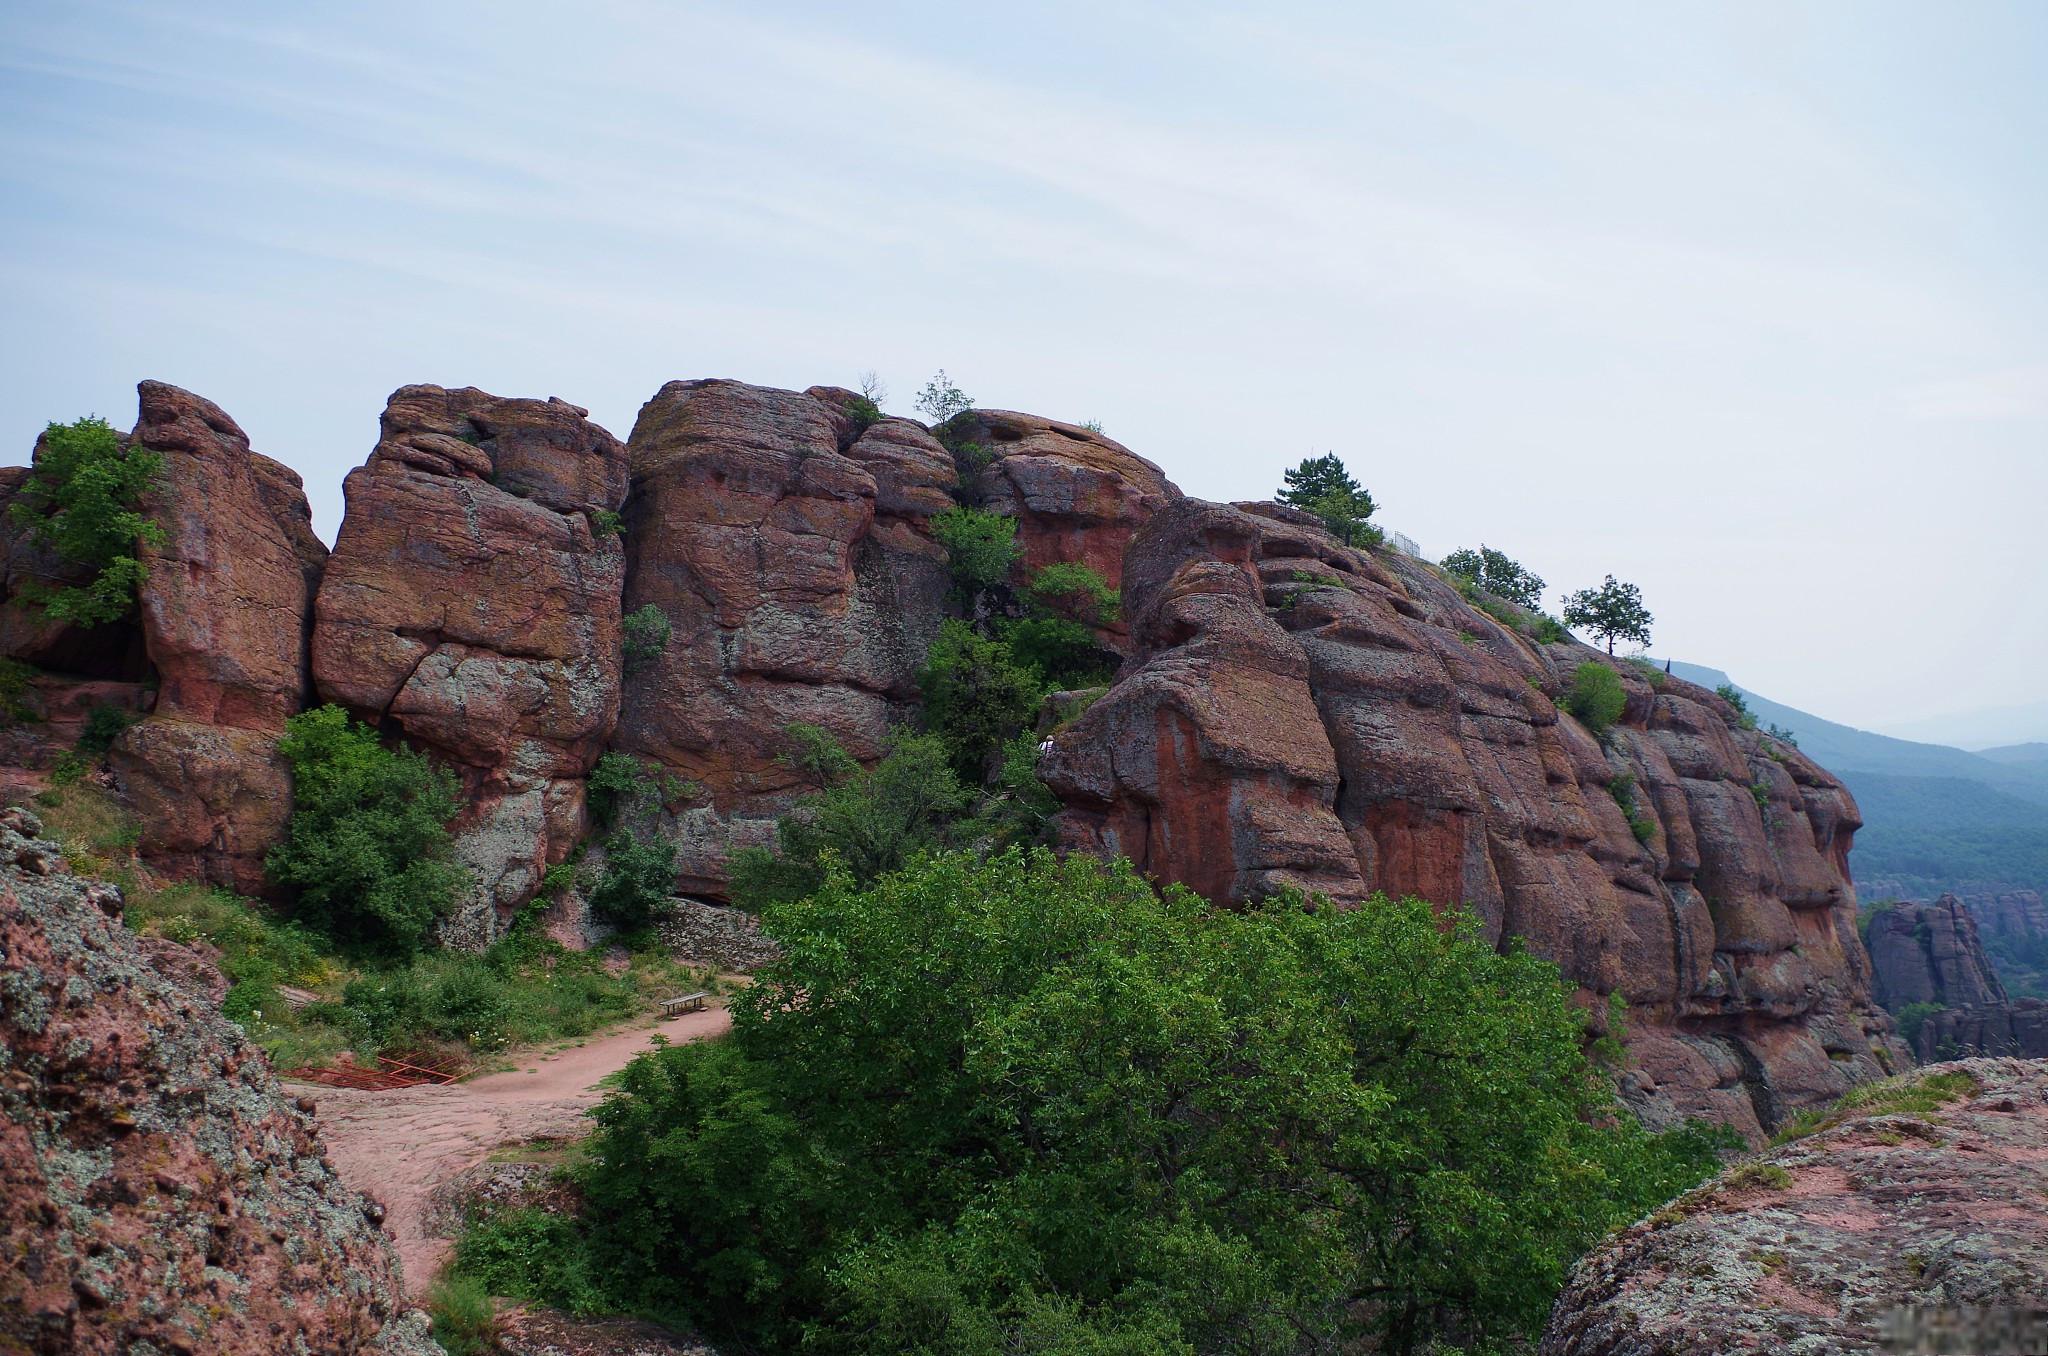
[264,705,469,952]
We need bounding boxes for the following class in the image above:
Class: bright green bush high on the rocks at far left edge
[8,416,164,627]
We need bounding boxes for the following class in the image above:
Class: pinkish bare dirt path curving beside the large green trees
[293,1008,731,1295]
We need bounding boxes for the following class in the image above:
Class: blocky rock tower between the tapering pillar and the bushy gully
[616,381,956,899]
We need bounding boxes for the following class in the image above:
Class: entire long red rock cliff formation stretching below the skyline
[0,381,1905,1135]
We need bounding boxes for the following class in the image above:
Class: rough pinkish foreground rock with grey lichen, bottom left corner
[0,811,440,1356]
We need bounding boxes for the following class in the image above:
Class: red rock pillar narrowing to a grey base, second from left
[313,385,627,944]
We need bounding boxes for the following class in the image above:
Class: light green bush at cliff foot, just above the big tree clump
[731,727,975,912]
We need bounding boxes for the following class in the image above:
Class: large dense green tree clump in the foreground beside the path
[540,852,1714,1356]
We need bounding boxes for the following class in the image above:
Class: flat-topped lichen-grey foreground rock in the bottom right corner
[1542,1059,2048,1356]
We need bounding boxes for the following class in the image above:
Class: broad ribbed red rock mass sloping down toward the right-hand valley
[1042,500,1903,1135]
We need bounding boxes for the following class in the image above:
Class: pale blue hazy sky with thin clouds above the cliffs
[0,0,2048,745]
